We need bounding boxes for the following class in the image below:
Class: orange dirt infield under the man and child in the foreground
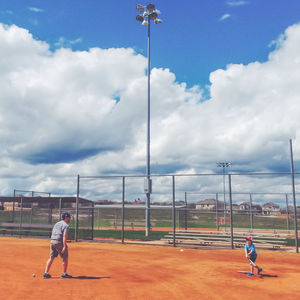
[0,237,300,300]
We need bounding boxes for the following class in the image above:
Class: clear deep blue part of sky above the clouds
[0,0,300,86]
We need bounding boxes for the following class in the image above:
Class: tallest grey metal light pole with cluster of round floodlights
[136,3,162,236]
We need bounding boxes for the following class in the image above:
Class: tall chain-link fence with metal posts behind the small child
[77,173,300,252]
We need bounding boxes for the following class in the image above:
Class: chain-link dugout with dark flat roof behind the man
[0,195,94,240]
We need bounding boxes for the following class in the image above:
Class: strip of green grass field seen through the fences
[0,208,300,230]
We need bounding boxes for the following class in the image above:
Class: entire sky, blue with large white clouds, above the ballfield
[0,0,300,204]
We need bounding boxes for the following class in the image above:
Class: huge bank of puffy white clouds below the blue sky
[0,24,300,202]
